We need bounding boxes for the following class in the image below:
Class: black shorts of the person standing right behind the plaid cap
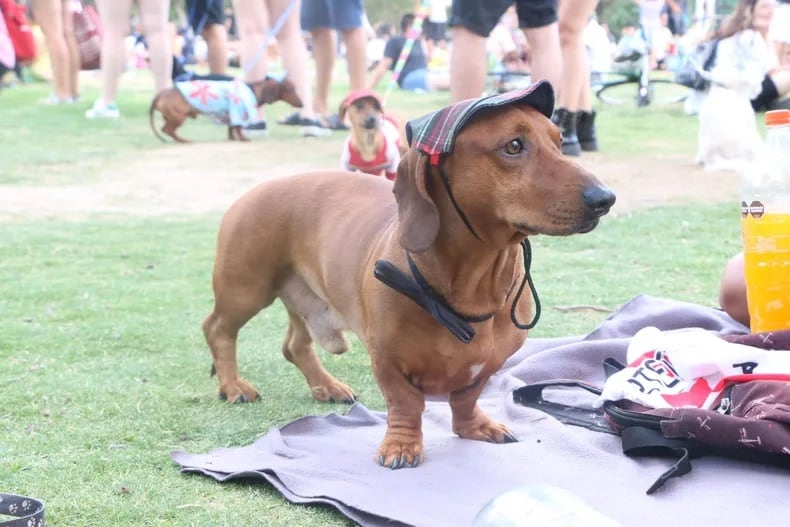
[450,0,557,37]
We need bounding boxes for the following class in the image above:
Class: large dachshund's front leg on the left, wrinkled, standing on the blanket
[376,367,425,469]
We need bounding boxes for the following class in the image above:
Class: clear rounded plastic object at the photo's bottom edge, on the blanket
[472,485,621,527]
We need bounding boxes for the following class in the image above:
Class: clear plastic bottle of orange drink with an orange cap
[741,110,790,333]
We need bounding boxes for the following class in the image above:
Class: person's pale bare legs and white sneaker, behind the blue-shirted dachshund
[85,0,173,119]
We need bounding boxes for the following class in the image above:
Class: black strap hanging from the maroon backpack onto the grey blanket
[620,426,697,494]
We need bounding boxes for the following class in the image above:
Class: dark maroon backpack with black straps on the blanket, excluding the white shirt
[513,354,790,494]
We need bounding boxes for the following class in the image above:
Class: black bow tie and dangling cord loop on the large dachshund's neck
[373,238,540,344]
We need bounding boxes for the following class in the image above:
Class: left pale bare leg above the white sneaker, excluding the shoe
[96,0,132,104]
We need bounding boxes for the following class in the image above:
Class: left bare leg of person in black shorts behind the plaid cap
[450,26,488,102]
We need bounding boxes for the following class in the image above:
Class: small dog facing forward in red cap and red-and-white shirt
[338,90,406,180]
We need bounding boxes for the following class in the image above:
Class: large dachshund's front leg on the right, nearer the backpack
[450,378,518,443]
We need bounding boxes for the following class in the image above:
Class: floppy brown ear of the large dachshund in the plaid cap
[393,148,439,253]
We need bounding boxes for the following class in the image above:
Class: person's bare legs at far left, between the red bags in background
[31,0,82,104]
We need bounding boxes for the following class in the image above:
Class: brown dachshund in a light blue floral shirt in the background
[148,75,302,143]
